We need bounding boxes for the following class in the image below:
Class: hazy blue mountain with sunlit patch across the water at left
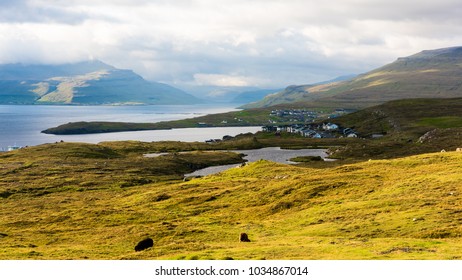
[0,60,201,105]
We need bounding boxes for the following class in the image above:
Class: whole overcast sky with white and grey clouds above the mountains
[0,0,462,91]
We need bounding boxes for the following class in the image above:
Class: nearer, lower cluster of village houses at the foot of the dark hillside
[262,123,358,138]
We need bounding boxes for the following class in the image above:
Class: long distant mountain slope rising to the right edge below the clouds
[244,47,462,108]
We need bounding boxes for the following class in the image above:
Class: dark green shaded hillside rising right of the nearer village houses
[326,98,462,159]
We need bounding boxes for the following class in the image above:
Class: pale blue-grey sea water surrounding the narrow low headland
[0,105,259,150]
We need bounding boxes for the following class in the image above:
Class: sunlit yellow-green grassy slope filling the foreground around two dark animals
[0,142,462,259]
